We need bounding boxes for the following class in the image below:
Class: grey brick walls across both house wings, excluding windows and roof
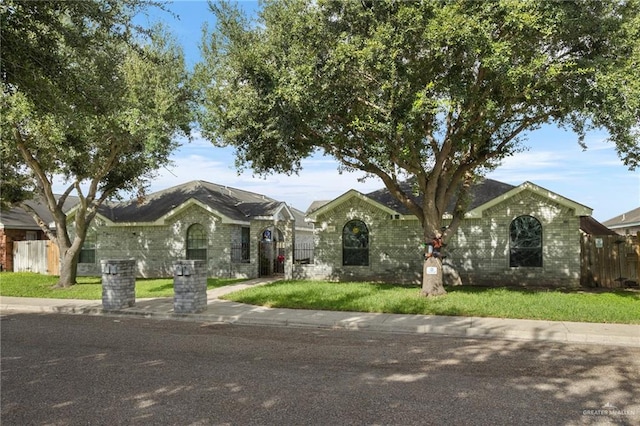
[78,190,580,286]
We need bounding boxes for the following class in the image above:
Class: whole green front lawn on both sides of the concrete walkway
[0,272,640,324]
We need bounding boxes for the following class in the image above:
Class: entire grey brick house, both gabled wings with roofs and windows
[6,179,604,286]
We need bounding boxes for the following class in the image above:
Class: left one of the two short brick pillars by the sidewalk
[100,259,136,311]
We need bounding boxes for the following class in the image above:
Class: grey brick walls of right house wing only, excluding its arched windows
[304,191,580,286]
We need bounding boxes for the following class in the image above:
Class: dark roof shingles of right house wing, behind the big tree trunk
[366,179,515,215]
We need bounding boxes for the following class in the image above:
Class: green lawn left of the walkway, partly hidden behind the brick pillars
[0,272,243,300]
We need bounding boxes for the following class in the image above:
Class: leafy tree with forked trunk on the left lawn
[0,0,192,286]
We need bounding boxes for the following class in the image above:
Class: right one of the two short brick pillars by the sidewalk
[173,260,207,314]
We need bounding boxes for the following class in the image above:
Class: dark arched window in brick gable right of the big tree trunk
[509,216,542,267]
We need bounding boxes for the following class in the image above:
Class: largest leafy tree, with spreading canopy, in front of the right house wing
[197,0,640,295]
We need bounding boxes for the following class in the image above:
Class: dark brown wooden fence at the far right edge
[581,232,640,288]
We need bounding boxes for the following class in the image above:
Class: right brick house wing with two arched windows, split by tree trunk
[302,180,592,286]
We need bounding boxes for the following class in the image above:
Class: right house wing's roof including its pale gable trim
[307,179,592,219]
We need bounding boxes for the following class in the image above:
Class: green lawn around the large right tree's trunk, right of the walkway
[223,281,640,324]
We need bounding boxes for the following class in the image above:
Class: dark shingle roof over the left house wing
[100,180,283,223]
